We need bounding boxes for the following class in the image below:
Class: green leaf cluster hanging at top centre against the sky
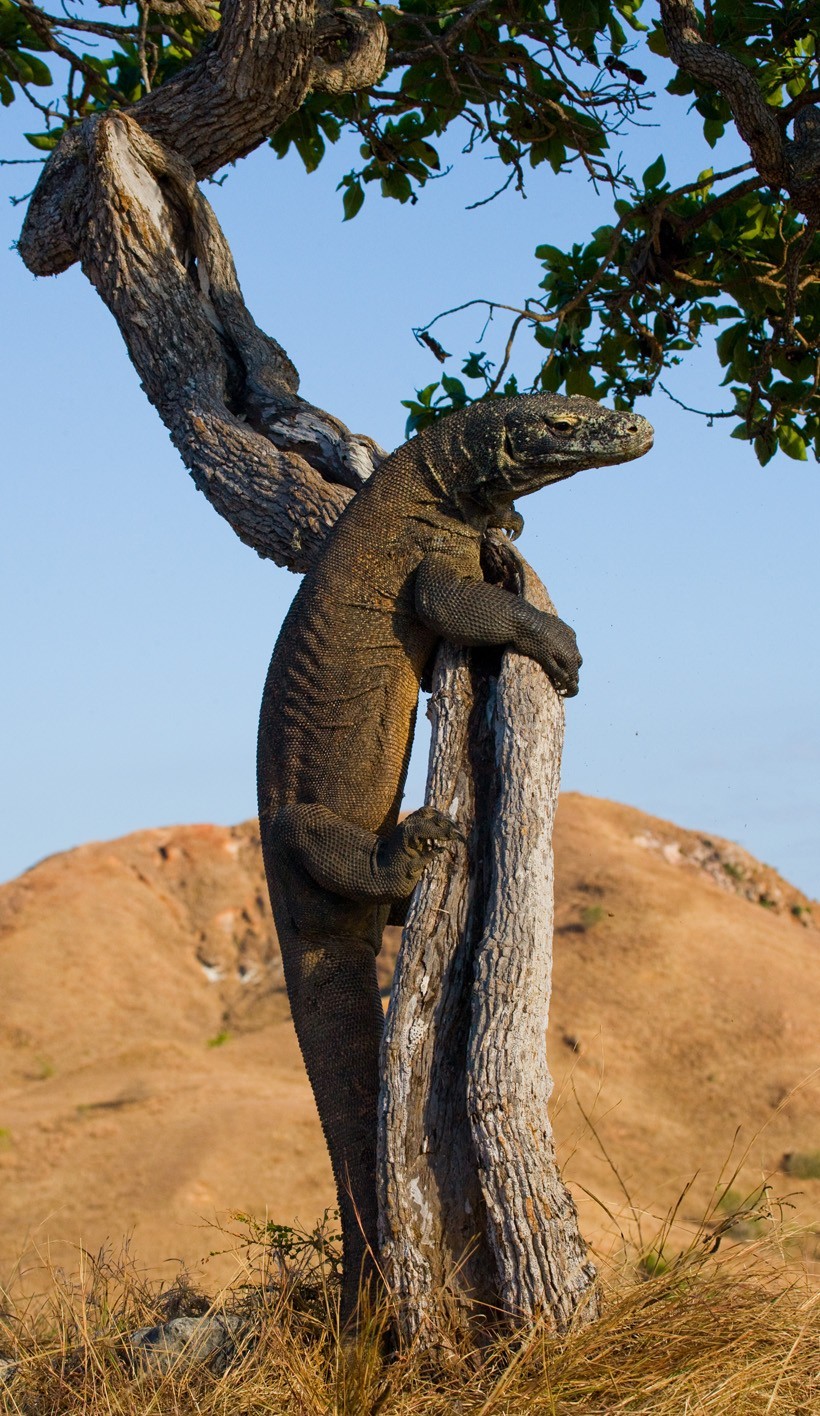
[271,0,646,219]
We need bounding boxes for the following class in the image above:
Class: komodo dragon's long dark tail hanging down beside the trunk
[280,935,384,1325]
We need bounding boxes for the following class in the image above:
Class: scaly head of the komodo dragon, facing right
[422,394,653,525]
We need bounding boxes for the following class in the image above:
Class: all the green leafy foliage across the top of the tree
[0,0,820,463]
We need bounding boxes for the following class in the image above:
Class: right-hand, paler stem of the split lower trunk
[466,568,599,1328]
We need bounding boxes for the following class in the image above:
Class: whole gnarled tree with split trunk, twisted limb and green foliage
[6,0,820,1330]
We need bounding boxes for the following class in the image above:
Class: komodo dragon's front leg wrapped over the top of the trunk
[415,551,582,698]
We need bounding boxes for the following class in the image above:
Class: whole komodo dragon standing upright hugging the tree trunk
[258,394,653,1318]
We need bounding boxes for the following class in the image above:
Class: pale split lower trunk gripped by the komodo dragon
[380,547,599,1341]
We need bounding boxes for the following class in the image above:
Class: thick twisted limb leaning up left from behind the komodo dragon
[66,112,384,571]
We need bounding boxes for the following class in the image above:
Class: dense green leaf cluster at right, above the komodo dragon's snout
[411,167,820,463]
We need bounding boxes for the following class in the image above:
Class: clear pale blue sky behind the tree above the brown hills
[0,55,820,896]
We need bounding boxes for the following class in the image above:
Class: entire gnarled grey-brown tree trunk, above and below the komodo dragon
[20,0,598,1334]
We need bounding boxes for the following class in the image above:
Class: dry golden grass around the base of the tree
[0,1206,820,1416]
